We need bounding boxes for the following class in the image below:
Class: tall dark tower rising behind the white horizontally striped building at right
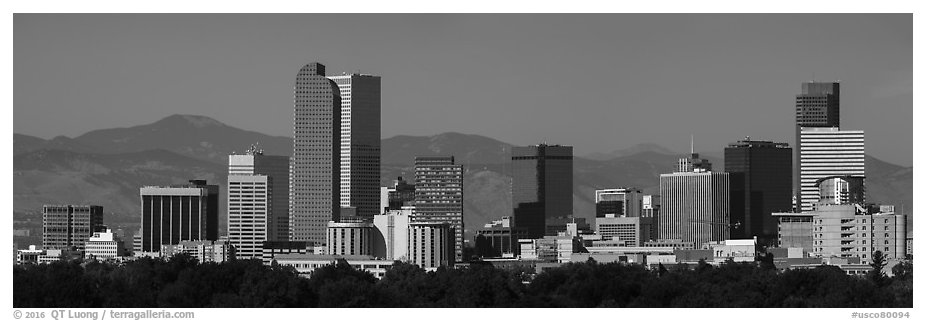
[791,82,839,211]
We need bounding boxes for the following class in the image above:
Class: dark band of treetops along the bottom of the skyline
[13,255,913,308]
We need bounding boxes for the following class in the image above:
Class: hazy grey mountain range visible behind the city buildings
[13,115,913,238]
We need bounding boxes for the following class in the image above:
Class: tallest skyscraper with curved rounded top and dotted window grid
[289,62,341,244]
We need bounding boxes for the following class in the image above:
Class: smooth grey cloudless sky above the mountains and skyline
[14,14,913,165]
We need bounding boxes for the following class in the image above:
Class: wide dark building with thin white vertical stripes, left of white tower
[140,180,219,252]
